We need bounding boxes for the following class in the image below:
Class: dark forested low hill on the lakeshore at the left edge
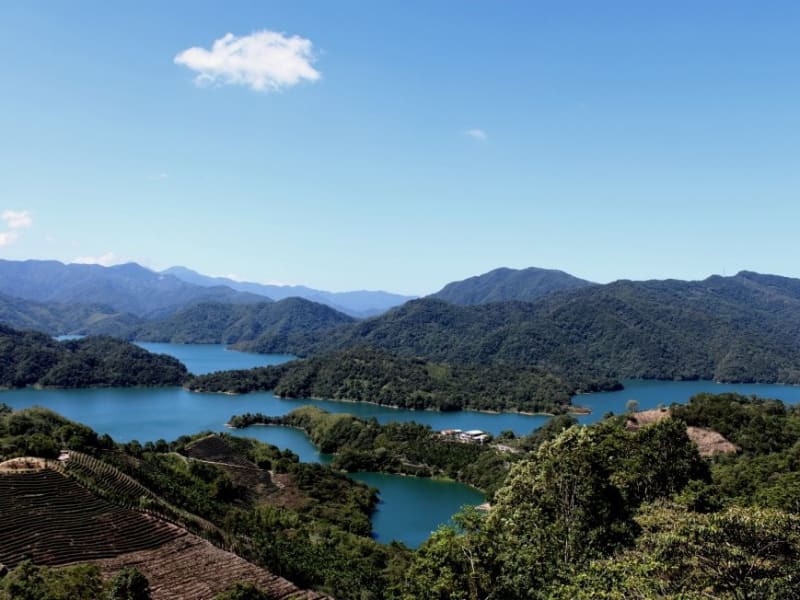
[0,325,187,388]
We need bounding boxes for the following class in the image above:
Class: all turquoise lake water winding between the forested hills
[0,343,800,546]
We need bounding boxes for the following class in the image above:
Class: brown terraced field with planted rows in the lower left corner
[0,461,327,600]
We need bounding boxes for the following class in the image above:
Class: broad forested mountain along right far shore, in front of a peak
[253,272,800,383]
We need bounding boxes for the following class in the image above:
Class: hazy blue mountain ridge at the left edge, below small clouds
[0,260,269,316]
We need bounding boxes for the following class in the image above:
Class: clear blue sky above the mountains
[0,0,800,294]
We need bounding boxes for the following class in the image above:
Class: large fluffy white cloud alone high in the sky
[175,30,320,92]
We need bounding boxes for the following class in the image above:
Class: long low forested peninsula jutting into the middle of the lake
[187,348,574,413]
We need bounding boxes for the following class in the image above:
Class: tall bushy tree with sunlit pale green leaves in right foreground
[486,427,636,600]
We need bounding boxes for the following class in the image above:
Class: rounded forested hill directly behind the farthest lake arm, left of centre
[97,298,354,344]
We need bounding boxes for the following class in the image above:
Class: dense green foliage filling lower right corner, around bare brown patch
[404,394,800,600]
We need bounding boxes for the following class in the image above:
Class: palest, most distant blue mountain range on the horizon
[162,267,413,318]
